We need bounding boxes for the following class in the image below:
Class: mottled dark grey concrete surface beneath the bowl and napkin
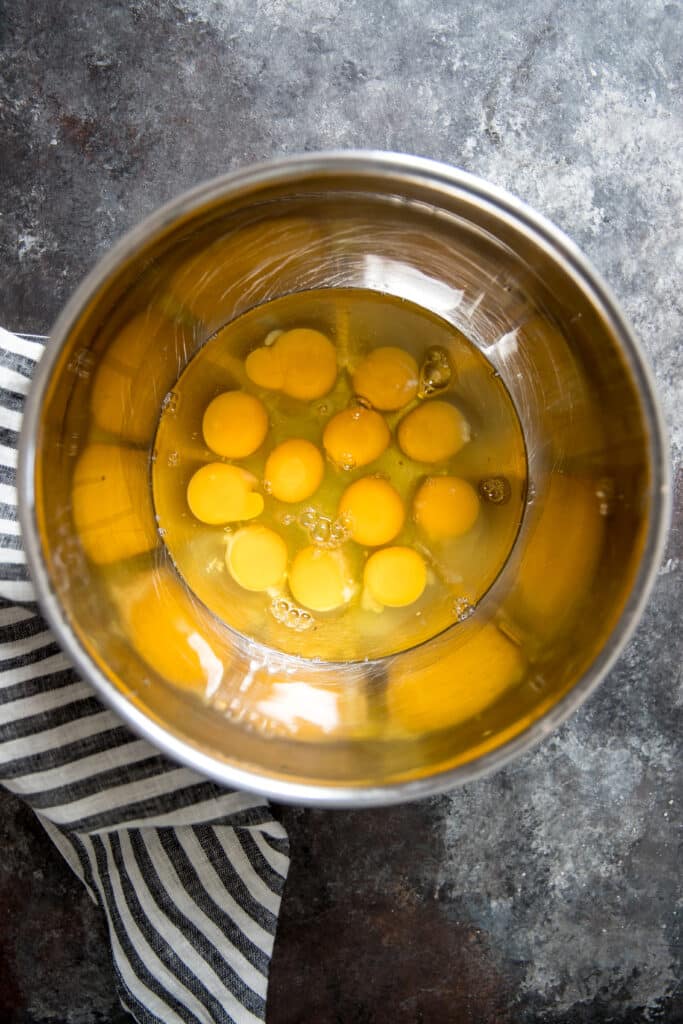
[0,0,683,1024]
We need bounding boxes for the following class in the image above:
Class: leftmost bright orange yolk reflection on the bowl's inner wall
[72,444,159,565]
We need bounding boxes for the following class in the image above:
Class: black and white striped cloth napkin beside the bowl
[0,328,289,1024]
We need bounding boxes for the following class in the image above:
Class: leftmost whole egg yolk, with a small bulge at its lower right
[187,462,263,525]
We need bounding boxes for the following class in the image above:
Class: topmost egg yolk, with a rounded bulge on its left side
[245,328,337,401]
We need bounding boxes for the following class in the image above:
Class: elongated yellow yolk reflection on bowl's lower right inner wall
[386,623,524,733]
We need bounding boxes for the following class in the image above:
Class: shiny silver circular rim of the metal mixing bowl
[16,150,671,808]
